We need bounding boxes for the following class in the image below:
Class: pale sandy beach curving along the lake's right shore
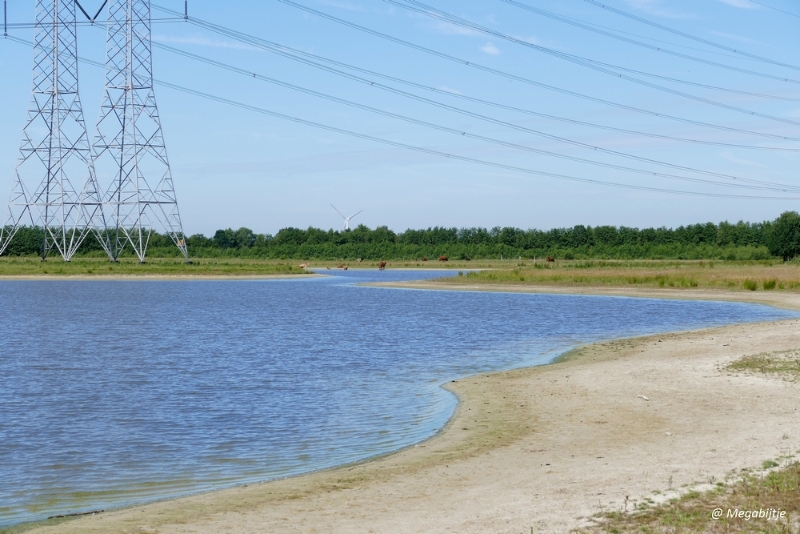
[18,283,800,534]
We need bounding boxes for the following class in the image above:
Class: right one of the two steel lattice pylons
[92,0,189,262]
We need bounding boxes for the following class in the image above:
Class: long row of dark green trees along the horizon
[6,212,800,260]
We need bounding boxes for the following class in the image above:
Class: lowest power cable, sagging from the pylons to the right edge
[4,37,800,201]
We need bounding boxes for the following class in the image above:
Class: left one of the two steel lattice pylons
[0,0,100,261]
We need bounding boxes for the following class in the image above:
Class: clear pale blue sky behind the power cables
[0,0,800,234]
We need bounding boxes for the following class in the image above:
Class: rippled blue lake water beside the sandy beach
[0,271,796,525]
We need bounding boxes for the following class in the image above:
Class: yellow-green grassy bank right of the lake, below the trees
[439,260,800,291]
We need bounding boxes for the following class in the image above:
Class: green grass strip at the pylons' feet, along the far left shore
[0,257,304,277]
